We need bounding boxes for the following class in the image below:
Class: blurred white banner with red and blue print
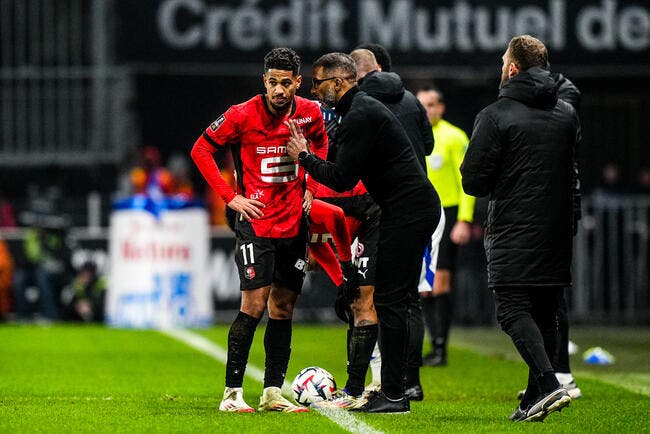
[106,208,214,328]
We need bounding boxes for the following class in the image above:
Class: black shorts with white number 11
[235,220,307,294]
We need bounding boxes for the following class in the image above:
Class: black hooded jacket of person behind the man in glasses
[359,71,434,173]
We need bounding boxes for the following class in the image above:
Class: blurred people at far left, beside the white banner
[0,186,106,322]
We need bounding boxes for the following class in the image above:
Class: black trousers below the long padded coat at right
[493,286,564,378]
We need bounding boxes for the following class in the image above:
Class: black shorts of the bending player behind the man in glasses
[319,193,381,286]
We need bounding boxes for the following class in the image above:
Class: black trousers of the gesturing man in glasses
[374,208,440,398]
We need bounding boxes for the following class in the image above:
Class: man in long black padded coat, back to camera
[461,35,580,420]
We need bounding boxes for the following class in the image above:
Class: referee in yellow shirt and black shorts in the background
[416,87,476,366]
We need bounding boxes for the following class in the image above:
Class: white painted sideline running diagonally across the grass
[160,328,383,434]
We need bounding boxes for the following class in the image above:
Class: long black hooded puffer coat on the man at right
[461,67,580,288]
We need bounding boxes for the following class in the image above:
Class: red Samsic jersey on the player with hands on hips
[192,95,327,238]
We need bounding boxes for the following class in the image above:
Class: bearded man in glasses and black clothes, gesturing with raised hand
[287,53,440,413]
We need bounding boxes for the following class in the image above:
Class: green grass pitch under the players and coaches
[0,324,650,434]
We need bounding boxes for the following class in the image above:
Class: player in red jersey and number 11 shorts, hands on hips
[191,48,327,412]
